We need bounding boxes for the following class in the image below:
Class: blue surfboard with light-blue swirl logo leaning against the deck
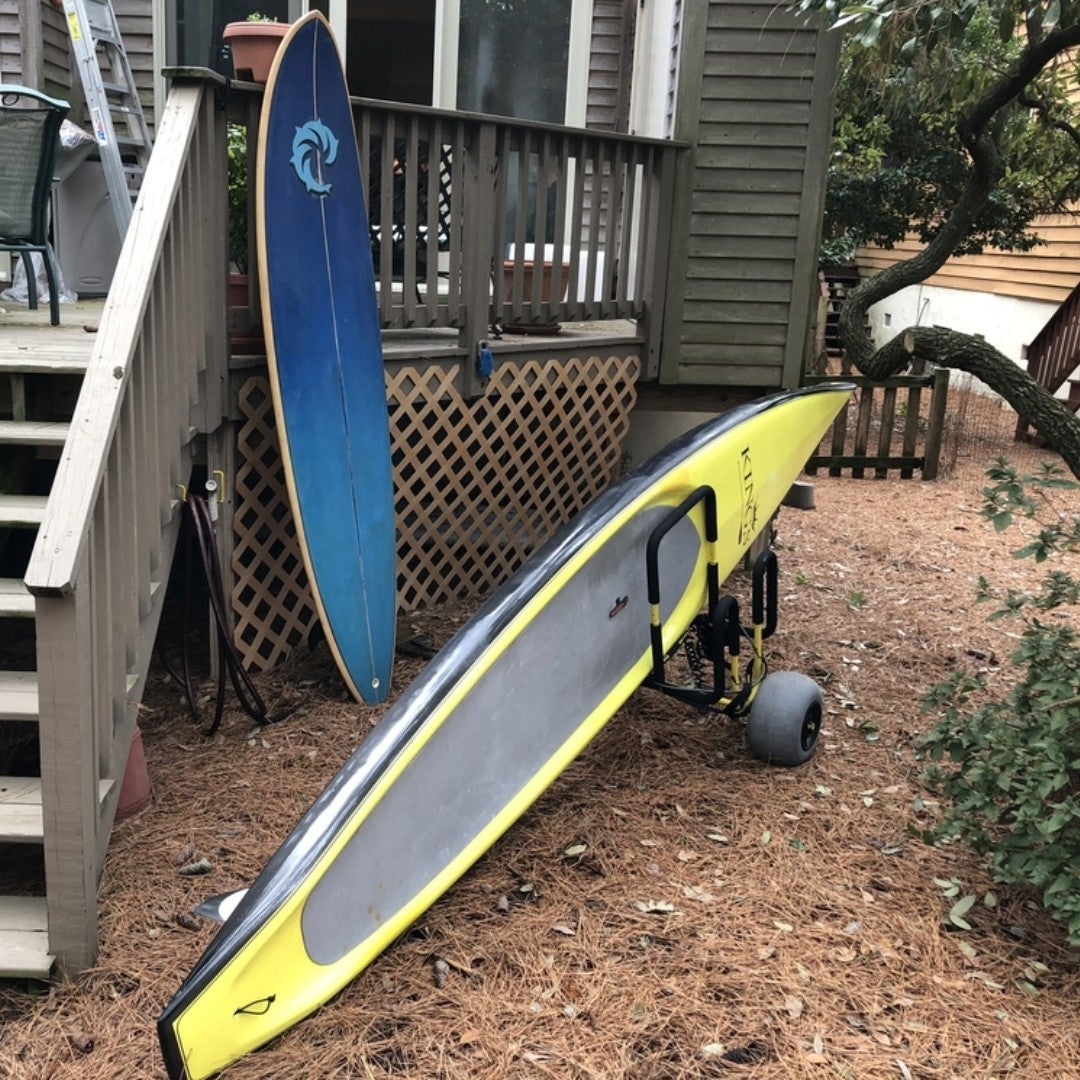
[256,12,396,703]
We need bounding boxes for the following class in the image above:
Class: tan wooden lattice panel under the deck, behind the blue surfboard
[232,355,640,670]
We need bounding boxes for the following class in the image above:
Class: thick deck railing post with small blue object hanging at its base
[458,123,497,401]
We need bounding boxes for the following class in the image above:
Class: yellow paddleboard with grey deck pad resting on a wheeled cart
[158,386,850,1080]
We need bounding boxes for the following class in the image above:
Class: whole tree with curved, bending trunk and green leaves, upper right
[793,0,1080,468]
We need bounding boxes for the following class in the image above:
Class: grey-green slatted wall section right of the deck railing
[661,0,839,389]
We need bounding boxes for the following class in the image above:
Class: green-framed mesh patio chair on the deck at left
[0,83,69,326]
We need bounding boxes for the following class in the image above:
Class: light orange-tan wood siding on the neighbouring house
[855,214,1080,303]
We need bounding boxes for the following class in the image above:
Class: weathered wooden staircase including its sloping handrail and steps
[0,84,231,980]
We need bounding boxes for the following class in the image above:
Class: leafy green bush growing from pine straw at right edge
[921,458,1080,945]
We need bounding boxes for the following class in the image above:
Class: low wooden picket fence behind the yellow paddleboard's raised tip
[804,368,949,480]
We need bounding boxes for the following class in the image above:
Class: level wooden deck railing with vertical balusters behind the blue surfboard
[230,83,683,388]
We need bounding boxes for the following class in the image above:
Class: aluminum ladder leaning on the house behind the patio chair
[64,0,150,241]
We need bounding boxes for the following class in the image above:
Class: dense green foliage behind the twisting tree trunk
[822,2,1080,266]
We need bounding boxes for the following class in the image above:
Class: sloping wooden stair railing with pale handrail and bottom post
[26,78,227,970]
